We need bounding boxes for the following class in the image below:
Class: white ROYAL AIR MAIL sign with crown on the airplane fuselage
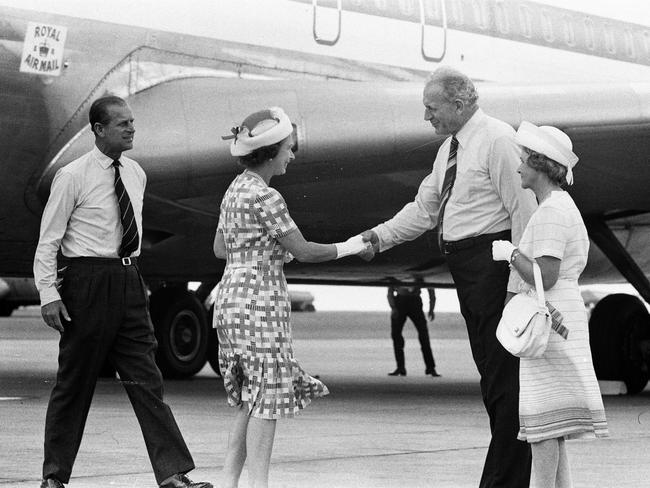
[20,22,68,76]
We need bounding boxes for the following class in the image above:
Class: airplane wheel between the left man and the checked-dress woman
[150,288,208,378]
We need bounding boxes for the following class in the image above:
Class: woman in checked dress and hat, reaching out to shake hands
[214,107,366,487]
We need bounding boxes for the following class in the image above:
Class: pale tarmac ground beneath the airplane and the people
[0,307,650,488]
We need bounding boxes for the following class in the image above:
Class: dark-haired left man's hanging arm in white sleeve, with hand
[34,171,75,331]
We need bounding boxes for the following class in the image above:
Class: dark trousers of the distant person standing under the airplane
[390,295,436,371]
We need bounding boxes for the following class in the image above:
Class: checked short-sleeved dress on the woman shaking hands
[213,171,329,419]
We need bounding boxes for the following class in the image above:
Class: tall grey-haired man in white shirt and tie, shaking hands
[364,67,535,488]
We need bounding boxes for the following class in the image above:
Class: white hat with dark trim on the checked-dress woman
[222,107,293,156]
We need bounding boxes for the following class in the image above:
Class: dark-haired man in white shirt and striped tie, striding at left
[34,96,212,488]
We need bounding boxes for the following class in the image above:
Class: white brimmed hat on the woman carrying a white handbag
[515,120,578,185]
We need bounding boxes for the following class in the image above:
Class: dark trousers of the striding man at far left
[43,258,194,484]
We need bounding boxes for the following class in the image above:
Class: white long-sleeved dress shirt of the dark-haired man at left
[34,147,147,306]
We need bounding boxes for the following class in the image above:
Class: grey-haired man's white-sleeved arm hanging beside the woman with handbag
[488,136,537,293]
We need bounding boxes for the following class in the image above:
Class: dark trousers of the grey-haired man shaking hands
[447,233,531,488]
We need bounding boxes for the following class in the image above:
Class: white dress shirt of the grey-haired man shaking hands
[372,109,537,292]
